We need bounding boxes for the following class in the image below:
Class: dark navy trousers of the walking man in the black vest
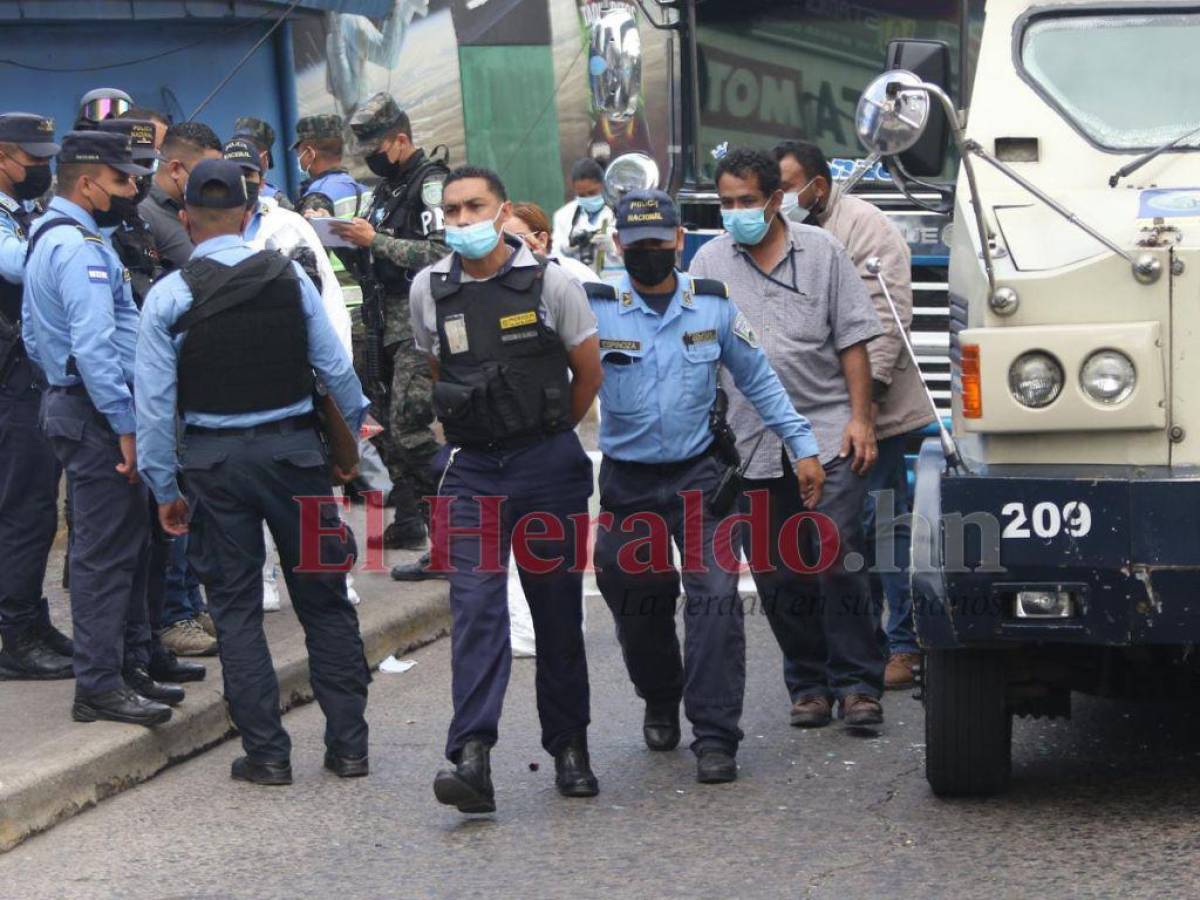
[432,431,592,762]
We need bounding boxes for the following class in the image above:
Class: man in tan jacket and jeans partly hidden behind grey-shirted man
[775,140,934,689]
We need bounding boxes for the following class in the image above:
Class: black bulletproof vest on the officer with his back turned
[170,251,313,414]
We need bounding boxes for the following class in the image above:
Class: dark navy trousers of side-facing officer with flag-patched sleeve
[42,388,151,695]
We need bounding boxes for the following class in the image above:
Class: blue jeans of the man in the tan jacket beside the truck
[864,434,919,653]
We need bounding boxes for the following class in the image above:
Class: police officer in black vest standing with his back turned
[134,160,370,785]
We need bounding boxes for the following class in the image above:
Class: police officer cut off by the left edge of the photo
[0,113,72,680]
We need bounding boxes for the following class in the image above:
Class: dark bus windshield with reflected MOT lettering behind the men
[696,0,983,188]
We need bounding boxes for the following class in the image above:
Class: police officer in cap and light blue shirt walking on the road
[586,191,821,784]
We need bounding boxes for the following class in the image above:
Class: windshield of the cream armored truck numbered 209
[1021,11,1200,151]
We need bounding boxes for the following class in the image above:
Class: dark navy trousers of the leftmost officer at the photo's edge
[0,362,60,642]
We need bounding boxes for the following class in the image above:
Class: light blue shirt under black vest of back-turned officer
[136,235,368,503]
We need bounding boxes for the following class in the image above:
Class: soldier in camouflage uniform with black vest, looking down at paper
[341,92,449,564]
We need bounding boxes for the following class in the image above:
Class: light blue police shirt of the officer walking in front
[592,271,818,463]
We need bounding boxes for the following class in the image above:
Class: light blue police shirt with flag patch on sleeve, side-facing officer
[22,197,138,434]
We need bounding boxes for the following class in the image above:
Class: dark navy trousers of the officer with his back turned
[180,427,371,762]
